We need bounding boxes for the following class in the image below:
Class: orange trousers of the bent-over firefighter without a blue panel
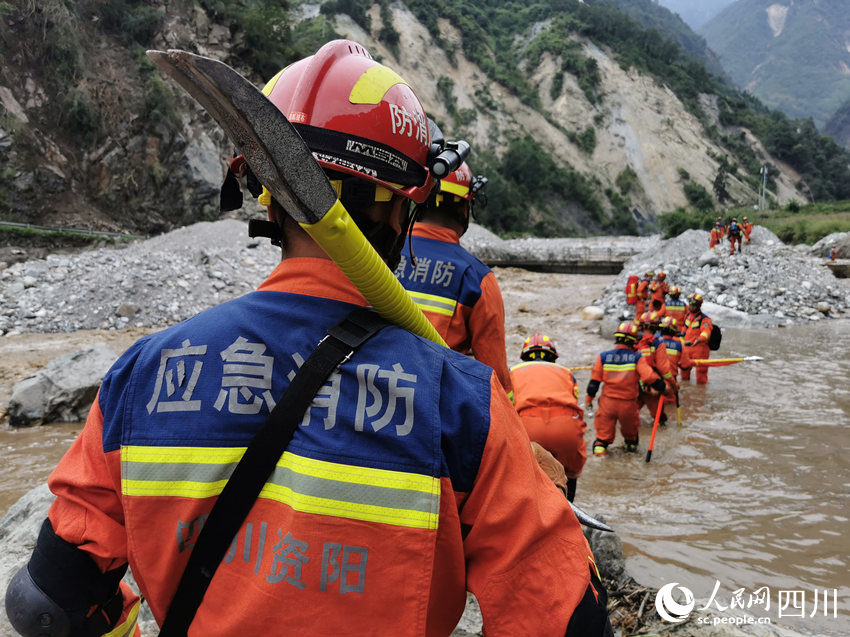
[519,406,587,478]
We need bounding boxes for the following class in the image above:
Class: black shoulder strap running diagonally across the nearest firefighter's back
[159,308,389,637]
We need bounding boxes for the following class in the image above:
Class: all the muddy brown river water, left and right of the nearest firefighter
[0,268,850,636]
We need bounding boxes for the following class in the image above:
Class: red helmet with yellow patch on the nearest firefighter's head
[261,40,436,203]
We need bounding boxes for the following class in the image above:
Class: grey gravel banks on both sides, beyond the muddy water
[0,219,850,334]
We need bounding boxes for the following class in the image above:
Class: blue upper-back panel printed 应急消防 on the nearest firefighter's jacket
[100,291,491,488]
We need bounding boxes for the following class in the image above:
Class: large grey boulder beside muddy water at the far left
[9,343,117,427]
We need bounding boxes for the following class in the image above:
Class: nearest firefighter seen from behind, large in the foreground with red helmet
[0,40,612,637]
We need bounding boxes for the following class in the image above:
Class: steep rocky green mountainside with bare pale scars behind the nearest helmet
[0,0,836,234]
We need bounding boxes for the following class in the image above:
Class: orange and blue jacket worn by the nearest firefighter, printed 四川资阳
[44,258,594,637]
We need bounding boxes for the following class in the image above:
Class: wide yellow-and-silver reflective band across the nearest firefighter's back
[121,447,440,529]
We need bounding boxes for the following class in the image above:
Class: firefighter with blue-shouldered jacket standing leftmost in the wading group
[585,321,665,456]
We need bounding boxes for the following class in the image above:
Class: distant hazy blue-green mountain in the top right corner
[700,0,850,126]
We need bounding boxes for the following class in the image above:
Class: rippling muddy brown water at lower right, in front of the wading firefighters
[576,320,850,635]
